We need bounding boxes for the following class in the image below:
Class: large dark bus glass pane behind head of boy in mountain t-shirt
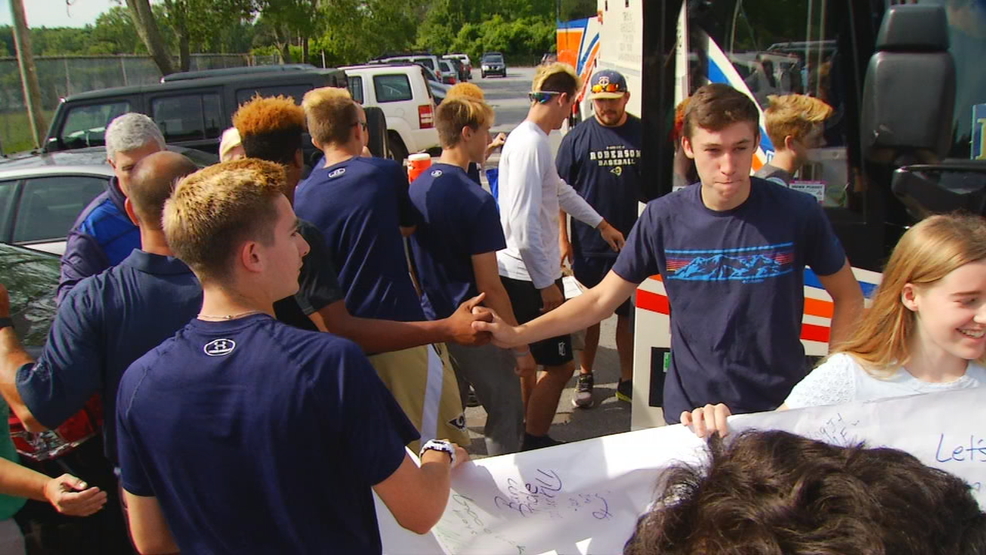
[688,0,863,213]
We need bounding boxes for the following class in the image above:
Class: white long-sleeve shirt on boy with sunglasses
[496,120,603,289]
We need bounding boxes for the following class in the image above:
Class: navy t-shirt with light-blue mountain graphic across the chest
[613,178,846,423]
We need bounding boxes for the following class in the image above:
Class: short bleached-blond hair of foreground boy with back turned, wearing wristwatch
[163,158,287,281]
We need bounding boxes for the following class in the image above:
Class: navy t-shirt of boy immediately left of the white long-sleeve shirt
[411,164,507,320]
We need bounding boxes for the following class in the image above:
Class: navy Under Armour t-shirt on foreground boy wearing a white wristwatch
[117,314,418,554]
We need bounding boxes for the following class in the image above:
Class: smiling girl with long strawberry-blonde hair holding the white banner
[681,215,986,437]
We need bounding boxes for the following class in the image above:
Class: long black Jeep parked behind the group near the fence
[43,66,358,161]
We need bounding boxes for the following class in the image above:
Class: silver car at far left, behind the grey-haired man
[0,146,218,255]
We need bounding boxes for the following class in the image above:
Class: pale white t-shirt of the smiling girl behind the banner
[784,353,986,409]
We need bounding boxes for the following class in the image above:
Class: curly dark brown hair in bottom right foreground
[624,431,986,555]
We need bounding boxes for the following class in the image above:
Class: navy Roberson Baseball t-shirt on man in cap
[555,114,643,258]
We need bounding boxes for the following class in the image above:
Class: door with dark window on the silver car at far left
[6,175,109,255]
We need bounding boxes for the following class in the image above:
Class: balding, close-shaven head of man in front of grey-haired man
[128,150,199,230]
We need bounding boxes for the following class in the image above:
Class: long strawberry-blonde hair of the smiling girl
[832,214,986,377]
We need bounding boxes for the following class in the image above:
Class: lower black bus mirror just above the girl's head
[891,161,986,220]
